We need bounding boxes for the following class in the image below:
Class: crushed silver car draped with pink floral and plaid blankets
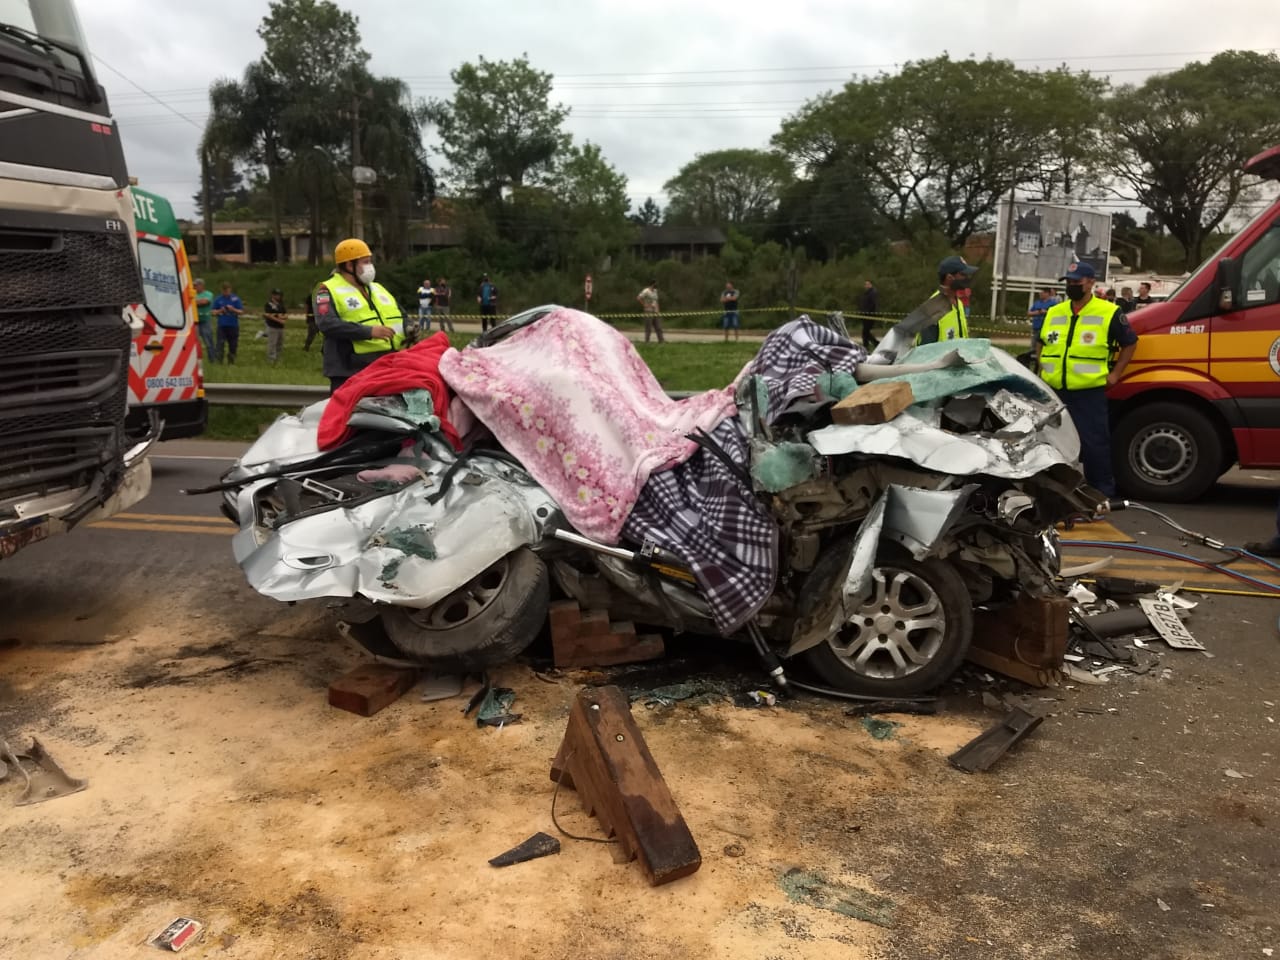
[204,303,1101,696]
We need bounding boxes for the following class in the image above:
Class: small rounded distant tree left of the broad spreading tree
[663,148,792,228]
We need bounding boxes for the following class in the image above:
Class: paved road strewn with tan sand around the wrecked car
[0,443,1280,960]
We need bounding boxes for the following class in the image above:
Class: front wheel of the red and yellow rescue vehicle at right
[1111,401,1226,503]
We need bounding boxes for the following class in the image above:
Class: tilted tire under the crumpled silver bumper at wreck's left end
[381,547,550,673]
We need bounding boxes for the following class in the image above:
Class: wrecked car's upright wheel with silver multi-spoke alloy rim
[803,544,973,699]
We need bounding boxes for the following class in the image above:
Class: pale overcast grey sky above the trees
[78,0,1280,216]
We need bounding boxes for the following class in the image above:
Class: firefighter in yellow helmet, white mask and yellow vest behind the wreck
[311,239,404,393]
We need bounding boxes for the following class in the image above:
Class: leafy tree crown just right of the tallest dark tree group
[428,56,570,201]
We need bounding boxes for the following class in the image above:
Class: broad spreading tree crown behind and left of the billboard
[773,55,1090,246]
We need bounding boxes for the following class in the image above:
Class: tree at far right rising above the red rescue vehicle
[1110,50,1280,270]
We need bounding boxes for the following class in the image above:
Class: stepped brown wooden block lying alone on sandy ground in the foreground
[552,686,703,886]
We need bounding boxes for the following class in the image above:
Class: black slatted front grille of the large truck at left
[0,230,143,516]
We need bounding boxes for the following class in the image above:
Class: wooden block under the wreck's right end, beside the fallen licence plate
[969,595,1071,686]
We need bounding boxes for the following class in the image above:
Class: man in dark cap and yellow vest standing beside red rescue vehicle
[1038,264,1138,497]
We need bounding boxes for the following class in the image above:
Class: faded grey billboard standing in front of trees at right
[996,200,1111,288]
